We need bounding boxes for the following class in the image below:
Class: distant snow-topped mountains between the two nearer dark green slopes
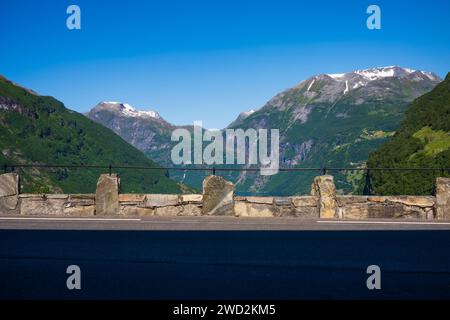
[87,66,441,195]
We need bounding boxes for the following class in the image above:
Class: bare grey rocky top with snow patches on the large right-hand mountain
[264,66,441,112]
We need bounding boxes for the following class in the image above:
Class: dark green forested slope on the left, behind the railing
[0,77,182,193]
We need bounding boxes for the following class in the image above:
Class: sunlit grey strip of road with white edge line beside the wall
[0,216,450,231]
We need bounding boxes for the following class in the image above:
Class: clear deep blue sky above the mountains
[0,0,450,128]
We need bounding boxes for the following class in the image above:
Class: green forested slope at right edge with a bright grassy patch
[368,73,450,194]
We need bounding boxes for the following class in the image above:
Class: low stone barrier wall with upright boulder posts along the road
[0,173,450,219]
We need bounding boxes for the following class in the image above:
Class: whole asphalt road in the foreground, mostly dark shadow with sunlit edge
[0,217,450,299]
